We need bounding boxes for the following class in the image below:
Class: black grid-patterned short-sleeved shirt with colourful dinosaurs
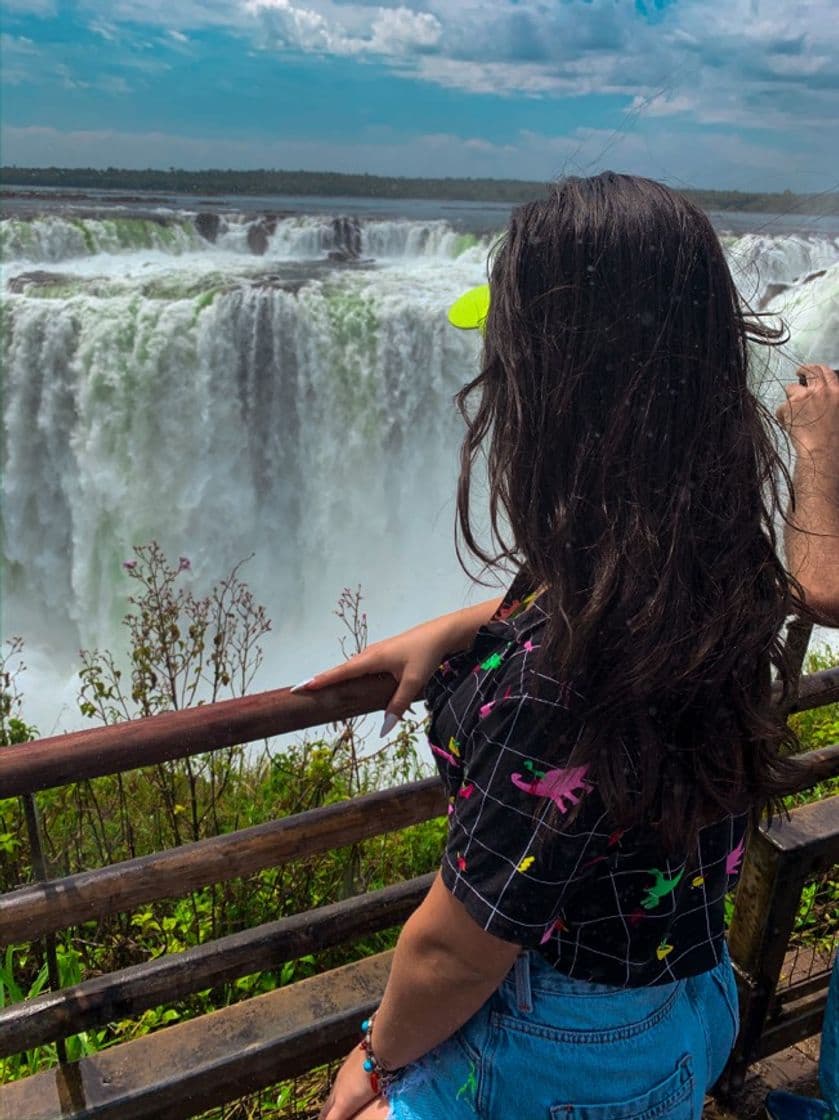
[426,575,746,988]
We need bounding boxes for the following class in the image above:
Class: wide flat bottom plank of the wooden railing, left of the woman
[0,952,393,1120]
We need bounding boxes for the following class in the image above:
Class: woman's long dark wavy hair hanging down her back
[456,171,803,849]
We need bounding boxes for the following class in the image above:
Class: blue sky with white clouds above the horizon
[0,0,839,193]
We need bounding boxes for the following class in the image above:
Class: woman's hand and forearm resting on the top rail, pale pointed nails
[291,598,501,736]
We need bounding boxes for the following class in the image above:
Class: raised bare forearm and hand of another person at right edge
[776,365,839,626]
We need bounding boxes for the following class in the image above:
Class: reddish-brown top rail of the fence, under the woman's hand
[0,669,839,797]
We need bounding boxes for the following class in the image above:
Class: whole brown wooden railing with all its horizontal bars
[0,670,839,1120]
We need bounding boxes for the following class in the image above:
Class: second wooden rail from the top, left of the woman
[0,778,446,945]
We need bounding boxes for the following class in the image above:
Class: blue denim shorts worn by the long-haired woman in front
[389,952,738,1120]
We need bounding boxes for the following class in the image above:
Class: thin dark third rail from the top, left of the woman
[0,872,434,1057]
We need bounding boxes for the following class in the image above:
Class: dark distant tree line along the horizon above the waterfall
[0,166,839,215]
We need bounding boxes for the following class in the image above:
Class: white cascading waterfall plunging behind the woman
[2,202,839,734]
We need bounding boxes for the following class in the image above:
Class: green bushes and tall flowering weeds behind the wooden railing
[0,543,839,1120]
